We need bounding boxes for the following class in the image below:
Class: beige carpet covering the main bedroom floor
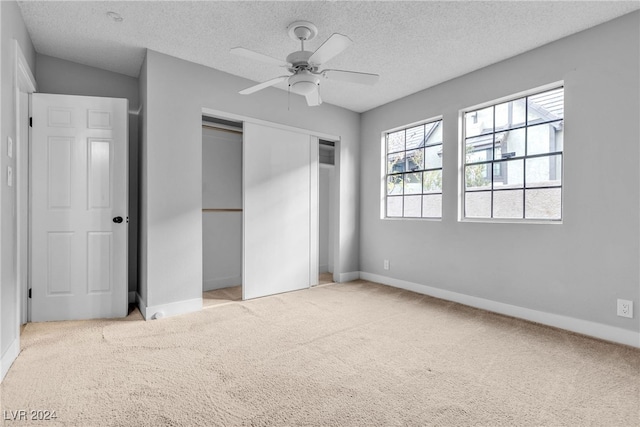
[1,282,640,427]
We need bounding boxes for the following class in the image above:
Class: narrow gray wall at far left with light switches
[0,1,35,366]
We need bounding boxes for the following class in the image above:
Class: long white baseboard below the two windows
[360,272,640,348]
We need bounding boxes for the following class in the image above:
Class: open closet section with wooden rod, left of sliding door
[202,116,243,307]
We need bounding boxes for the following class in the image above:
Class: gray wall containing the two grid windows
[360,12,640,331]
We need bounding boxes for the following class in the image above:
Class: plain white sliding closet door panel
[242,123,318,299]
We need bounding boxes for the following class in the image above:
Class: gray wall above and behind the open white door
[35,54,140,292]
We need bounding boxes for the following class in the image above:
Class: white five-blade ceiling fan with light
[231,21,380,107]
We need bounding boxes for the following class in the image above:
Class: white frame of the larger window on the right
[458,81,566,224]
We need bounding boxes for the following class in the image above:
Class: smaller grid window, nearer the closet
[385,120,442,218]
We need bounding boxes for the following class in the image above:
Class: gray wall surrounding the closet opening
[140,51,360,306]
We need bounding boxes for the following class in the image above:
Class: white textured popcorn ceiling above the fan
[18,0,640,112]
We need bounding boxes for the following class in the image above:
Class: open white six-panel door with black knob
[30,94,128,321]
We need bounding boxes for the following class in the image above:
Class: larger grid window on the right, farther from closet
[463,87,564,220]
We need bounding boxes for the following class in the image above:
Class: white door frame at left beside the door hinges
[13,40,37,326]
